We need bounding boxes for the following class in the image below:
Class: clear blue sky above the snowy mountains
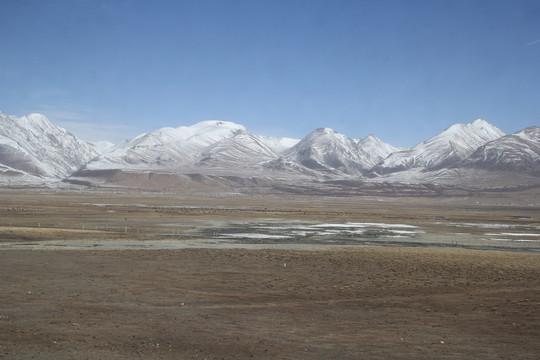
[0,0,540,146]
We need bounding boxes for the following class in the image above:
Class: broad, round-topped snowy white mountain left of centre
[86,121,299,172]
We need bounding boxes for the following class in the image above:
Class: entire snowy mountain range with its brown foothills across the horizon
[0,112,540,192]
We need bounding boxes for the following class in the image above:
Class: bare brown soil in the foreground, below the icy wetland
[0,247,540,359]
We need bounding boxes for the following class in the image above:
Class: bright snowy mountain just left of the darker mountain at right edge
[370,119,505,176]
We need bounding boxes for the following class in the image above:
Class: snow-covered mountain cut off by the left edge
[0,112,98,179]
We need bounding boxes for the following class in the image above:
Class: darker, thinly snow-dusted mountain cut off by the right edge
[456,126,540,174]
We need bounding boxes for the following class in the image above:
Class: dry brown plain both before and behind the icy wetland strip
[0,192,540,359]
